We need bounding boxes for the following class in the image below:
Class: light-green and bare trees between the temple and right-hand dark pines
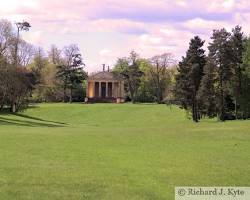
[113,52,175,103]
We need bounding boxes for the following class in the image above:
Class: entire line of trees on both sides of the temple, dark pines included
[0,20,250,122]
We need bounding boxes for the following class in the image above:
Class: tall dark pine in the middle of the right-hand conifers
[208,28,233,121]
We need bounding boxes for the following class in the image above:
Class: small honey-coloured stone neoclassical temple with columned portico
[85,67,124,103]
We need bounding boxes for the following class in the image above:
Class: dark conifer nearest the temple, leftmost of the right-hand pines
[175,36,206,122]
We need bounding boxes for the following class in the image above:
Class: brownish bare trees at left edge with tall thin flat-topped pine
[0,20,36,112]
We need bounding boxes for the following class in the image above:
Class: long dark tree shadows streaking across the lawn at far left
[0,114,67,127]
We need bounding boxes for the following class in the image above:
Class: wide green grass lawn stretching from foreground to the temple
[0,104,250,200]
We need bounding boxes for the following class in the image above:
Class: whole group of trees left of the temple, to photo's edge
[0,20,87,112]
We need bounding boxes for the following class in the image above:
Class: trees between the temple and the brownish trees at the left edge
[31,44,87,103]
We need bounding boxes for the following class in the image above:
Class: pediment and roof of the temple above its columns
[88,71,123,81]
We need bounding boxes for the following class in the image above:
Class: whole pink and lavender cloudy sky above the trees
[0,0,250,72]
